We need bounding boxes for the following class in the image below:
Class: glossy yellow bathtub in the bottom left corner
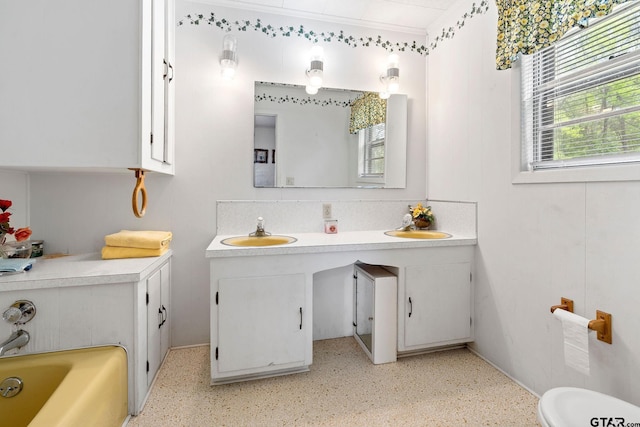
[0,346,128,427]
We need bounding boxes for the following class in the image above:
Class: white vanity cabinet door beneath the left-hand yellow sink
[217,274,307,375]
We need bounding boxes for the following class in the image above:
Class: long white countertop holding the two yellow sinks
[206,230,478,258]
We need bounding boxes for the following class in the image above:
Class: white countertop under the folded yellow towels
[0,250,172,292]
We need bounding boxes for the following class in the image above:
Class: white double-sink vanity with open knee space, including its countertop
[206,230,477,384]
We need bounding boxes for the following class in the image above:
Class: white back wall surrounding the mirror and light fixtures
[21,0,426,346]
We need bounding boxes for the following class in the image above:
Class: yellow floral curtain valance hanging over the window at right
[496,0,636,70]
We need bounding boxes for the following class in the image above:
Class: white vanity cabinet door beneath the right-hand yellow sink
[403,263,471,348]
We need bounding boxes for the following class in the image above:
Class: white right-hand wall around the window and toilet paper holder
[427,0,640,405]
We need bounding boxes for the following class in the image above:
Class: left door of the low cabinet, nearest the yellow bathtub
[143,270,163,385]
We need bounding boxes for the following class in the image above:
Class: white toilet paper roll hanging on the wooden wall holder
[553,308,589,375]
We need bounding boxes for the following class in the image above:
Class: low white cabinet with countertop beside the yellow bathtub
[0,250,172,415]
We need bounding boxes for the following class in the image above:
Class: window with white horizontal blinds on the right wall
[521,4,640,171]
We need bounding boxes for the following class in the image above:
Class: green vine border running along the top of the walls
[178,0,489,55]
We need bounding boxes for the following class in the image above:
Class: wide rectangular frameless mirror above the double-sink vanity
[253,82,407,188]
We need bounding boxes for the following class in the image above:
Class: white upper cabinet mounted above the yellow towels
[0,0,175,174]
